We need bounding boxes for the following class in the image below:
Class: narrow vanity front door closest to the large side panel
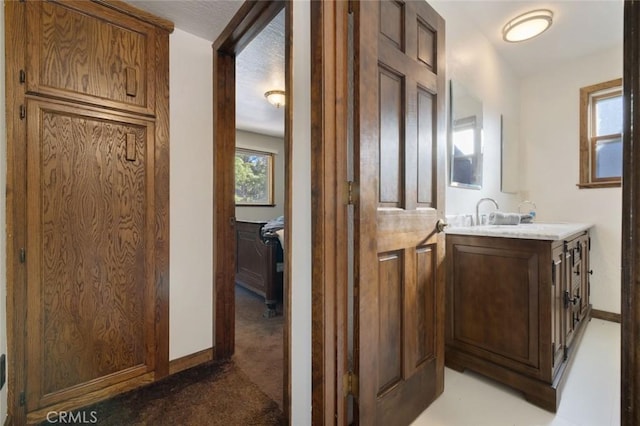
[551,245,565,377]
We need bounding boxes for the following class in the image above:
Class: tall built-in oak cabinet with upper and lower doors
[6,1,172,423]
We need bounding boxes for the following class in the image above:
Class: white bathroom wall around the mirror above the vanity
[429,0,522,220]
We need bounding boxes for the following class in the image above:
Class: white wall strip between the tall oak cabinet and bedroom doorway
[169,29,213,359]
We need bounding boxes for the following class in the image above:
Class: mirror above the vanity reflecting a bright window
[449,80,482,189]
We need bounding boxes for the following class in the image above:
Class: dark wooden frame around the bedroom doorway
[213,0,293,419]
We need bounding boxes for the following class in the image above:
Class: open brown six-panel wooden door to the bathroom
[354,1,446,425]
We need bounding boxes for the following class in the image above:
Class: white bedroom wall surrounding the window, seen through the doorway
[236,130,284,220]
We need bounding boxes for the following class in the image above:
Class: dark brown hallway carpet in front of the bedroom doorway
[42,362,284,426]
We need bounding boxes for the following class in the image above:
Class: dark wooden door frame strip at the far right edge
[621,1,640,426]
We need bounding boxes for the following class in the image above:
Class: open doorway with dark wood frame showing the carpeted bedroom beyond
[213,1,291,418]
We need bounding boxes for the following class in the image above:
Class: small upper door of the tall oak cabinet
[27,1,155,114]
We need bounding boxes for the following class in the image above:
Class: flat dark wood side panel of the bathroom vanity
[449,244,540,374]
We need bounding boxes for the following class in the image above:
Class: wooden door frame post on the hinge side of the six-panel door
[311,1,350,425]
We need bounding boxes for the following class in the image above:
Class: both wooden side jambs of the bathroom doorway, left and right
[311,0,640,426]
